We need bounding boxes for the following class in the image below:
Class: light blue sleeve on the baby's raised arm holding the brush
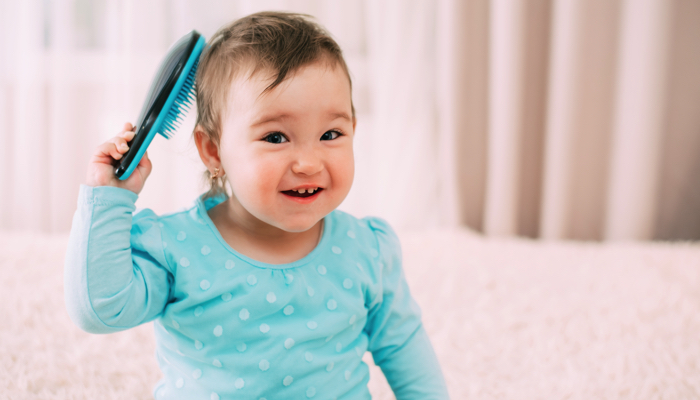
[64,185,172,333]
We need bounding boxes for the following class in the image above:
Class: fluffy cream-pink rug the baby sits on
[0,230,700,399]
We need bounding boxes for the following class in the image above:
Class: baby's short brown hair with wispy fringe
[196,11,355,197]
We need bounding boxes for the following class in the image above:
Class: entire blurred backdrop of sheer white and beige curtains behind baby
[0,0,700,240]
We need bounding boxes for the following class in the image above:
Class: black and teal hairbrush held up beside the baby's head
[114,31,205,180]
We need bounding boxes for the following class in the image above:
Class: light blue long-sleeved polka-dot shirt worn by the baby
[65,185,448,400]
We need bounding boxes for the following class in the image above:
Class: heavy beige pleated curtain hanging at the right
[440,0,700,240]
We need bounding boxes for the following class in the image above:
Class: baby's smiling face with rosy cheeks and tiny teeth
[219,62,355,232]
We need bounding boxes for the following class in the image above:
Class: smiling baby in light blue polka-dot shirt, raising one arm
[65,12,448,400]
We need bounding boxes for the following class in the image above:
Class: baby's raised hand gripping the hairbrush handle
[86,122,152,194]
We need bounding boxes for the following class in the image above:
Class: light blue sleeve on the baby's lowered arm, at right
[366,219,449,400]
